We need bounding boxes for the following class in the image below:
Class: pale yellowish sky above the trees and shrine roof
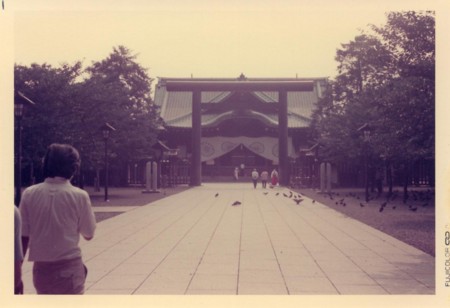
[10,0,430,82]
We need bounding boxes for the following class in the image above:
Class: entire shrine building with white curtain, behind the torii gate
[154,75,327,186]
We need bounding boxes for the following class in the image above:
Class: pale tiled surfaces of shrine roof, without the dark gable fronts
[155,78,326,128]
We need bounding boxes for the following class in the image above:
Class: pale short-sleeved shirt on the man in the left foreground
[20,177,96,261]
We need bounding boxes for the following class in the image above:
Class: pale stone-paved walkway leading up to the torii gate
[23,183,435,295]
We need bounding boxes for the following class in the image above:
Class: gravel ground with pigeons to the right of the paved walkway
[295,188,435,256]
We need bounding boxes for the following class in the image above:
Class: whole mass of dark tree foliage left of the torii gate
[14,46,162,180]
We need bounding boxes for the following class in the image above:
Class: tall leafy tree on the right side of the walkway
[312,12,435,194]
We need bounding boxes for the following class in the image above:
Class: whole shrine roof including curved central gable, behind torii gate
[155,78,327,128]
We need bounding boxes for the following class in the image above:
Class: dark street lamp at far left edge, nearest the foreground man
[14,91,35,206]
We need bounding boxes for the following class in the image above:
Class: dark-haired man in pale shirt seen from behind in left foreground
[19,144,96,294]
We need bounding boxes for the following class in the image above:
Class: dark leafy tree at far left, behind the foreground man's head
[14,62,81,183]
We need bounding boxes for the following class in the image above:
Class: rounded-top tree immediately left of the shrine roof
[79,46,161,171]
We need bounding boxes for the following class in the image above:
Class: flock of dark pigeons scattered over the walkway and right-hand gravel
[215,190,432,213]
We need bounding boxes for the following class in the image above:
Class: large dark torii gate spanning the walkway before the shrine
[166,79,314,186]
